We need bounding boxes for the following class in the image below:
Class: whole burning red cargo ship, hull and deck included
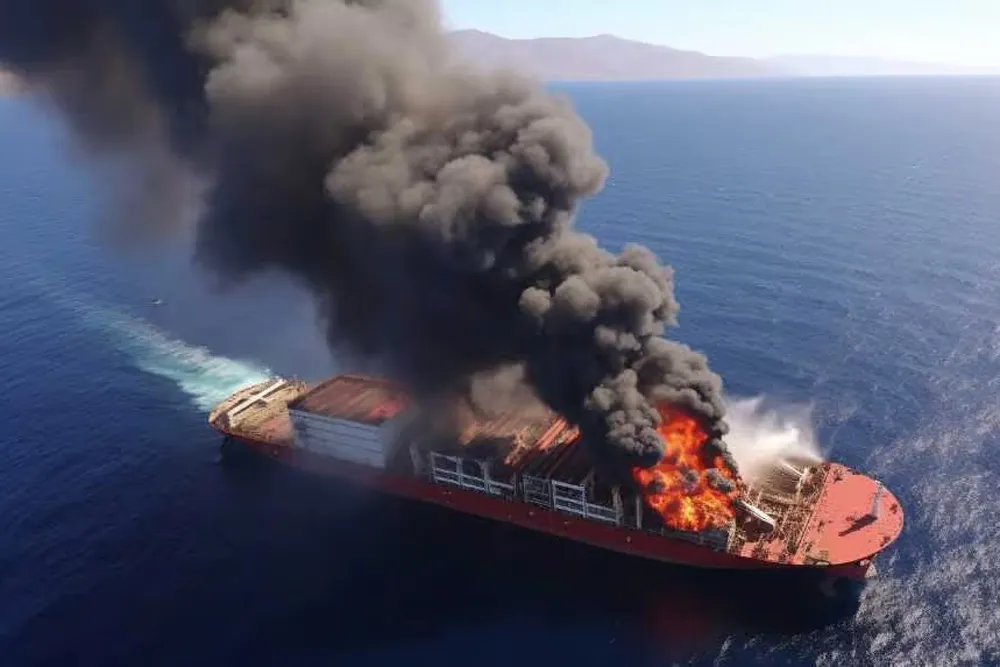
[209,374,903,581]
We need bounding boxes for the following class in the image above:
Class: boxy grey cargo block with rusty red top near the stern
[288,375,410,469]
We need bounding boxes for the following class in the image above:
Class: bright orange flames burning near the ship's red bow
[632,405,738,531]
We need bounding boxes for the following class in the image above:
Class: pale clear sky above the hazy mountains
[442,0,1000,66]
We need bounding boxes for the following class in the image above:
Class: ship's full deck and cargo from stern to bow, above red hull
[210,375,902,565]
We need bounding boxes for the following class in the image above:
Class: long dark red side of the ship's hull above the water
[218,429,871,581]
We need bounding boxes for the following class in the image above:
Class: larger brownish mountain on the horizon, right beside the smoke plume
[448,30,784,81]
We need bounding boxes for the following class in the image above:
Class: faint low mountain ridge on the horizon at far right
[764,55,1000,76]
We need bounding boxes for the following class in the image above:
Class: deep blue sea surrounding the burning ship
[0,79,1000,666]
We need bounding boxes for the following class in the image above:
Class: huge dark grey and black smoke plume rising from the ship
[0,0,725,474]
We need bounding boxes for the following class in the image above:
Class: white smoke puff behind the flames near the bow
[726,396,824,484]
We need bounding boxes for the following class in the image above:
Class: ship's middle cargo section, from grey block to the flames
[274,376,738,551]
